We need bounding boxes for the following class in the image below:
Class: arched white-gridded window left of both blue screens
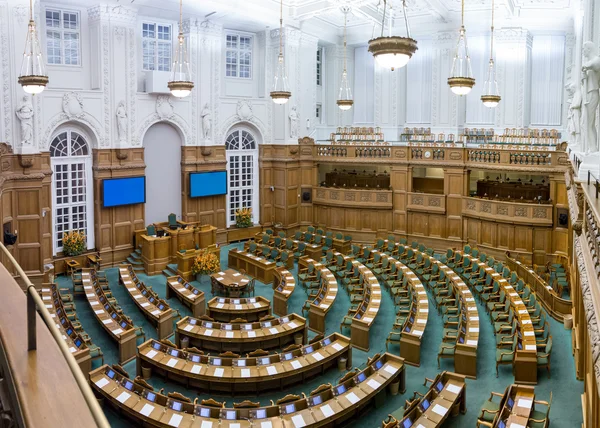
[50,129,95,255]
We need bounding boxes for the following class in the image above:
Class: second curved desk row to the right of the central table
[298,256,338,333]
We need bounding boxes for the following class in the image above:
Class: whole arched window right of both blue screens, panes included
[225,129,260,226]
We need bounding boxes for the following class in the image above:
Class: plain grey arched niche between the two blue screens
[143,122,182,224]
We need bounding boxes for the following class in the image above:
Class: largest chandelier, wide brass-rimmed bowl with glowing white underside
[369,0,418,71]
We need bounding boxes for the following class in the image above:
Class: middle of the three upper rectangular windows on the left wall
[142,22,173,71]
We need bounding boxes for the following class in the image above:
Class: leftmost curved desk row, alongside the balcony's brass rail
[40,284,92,373]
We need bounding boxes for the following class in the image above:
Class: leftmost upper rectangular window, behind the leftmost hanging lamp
[46,9,80,65]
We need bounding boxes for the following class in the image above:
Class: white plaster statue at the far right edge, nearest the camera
[581,42,600,154]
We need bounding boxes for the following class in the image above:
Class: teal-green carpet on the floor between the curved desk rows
[57,244,583,428]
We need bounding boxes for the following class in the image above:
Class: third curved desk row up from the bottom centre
[175,314,306,353]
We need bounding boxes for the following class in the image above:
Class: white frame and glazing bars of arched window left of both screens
[50,128,96,256]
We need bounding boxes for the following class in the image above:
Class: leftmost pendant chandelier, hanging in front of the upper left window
[18,0,48,95]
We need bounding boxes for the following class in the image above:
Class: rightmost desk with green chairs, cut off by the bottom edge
[477,384,552,428]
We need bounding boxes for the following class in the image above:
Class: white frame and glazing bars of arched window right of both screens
[225,127,260,227]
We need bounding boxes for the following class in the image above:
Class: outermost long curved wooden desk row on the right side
[456,251,537,384]
